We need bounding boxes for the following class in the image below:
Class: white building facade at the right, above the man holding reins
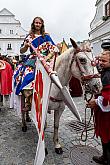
[89,0,110,56]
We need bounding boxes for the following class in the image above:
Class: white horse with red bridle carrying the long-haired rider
[48,40,101,154]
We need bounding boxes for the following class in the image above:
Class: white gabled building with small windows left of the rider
[0,8,27,59]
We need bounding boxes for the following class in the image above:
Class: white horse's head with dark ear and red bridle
[71,39,102,94]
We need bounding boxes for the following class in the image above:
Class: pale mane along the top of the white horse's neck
[55,48,73,70]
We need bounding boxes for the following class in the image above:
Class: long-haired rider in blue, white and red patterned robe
[14,17,58,95]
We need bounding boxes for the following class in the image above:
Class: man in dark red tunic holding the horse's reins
[87,49,110,165]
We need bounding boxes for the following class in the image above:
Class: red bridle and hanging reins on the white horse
[71,50,100,142]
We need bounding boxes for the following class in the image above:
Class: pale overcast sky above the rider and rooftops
[0,0,96,43]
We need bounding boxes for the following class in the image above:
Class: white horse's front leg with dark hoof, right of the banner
[53,106,64,154]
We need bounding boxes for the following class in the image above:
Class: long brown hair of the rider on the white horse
[30,17,45,37]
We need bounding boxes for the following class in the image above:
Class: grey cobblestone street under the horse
[0,97,102,165]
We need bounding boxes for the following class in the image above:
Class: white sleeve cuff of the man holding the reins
[96,96,110,112]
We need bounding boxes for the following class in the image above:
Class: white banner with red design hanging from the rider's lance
[31,59,51,165]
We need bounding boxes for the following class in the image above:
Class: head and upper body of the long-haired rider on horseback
[20,17,56,59]
